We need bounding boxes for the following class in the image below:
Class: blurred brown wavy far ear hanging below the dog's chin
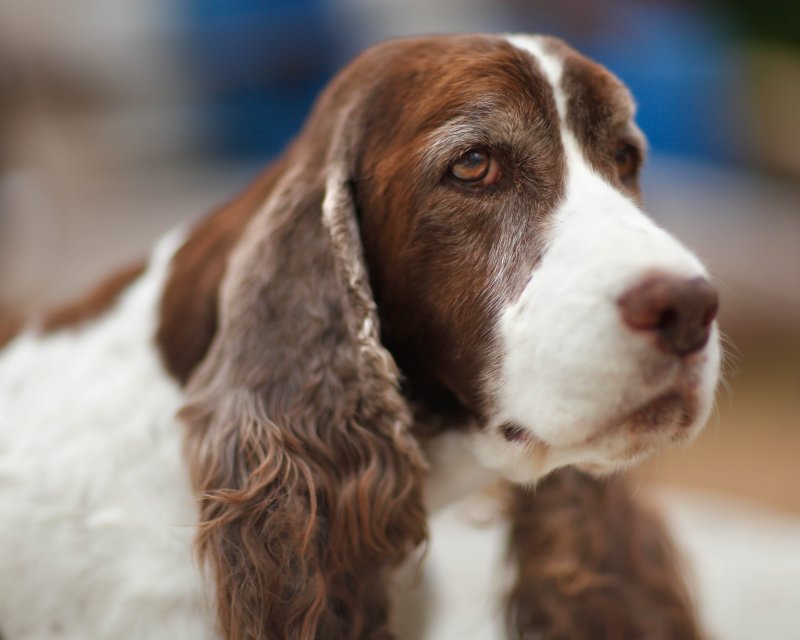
[507,469,701,640]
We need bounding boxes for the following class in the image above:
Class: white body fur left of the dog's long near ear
[0,235,214,640]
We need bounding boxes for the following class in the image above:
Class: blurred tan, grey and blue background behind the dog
[0,0,800,638]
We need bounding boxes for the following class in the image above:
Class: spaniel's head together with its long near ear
[177,36,720,638]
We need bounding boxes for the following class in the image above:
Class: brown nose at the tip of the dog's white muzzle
[618,274,719,356]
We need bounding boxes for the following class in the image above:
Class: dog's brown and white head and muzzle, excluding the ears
[322,36,720,481]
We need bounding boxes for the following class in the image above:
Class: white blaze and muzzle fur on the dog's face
[476,36,720,482]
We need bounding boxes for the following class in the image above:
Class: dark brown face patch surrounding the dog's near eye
[354,37,564,414]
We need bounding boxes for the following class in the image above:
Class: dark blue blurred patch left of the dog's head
[179,0,340,160]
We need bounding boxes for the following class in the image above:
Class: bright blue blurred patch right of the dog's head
[582,2,747,161]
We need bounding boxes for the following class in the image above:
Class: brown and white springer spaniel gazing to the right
[0,35,720,640]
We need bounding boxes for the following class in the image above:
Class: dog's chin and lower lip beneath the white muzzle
[476,389,707,484]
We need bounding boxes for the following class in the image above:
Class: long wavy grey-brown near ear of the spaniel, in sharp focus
[181,102,426,640]
